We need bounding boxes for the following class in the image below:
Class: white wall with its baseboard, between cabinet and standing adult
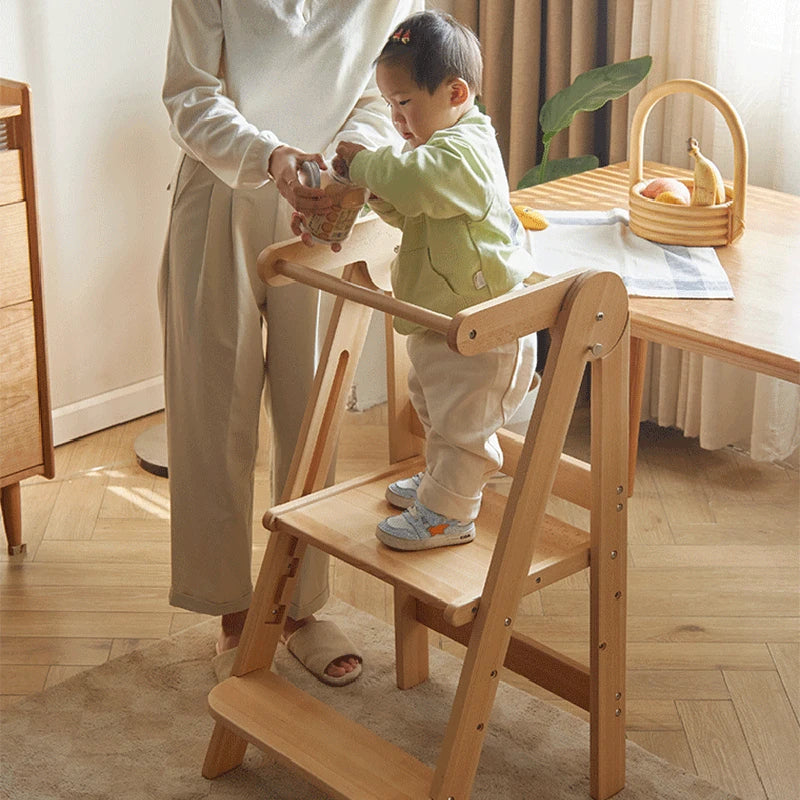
[0,0,177,443]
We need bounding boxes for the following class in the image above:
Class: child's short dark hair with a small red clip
[375,11,483,94]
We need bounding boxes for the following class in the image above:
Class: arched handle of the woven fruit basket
[628,78,747,242]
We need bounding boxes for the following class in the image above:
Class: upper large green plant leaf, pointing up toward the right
[539,56,653,142]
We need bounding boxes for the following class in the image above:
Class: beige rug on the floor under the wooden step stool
[0,601,733,800]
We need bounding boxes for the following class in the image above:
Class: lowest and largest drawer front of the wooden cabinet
[0,302,43,476]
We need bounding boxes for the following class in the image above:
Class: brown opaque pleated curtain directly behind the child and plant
[452,0,633,187]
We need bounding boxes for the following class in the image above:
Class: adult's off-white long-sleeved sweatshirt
[163,0,424,189]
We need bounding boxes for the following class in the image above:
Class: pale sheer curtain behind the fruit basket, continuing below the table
[630,0,800,461]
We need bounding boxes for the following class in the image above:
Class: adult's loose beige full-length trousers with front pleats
[159,157,329,619]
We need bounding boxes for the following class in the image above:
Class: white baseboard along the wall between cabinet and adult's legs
[53,375,164,446]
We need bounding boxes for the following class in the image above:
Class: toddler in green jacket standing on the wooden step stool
[333,11,536,550]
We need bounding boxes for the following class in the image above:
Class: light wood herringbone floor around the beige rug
[0,407,800,800]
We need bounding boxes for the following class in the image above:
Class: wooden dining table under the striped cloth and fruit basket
[511,162,800,493]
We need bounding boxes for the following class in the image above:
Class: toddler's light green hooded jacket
[350,106,533,334]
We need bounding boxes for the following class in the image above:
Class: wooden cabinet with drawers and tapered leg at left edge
[0,78,54,555]
